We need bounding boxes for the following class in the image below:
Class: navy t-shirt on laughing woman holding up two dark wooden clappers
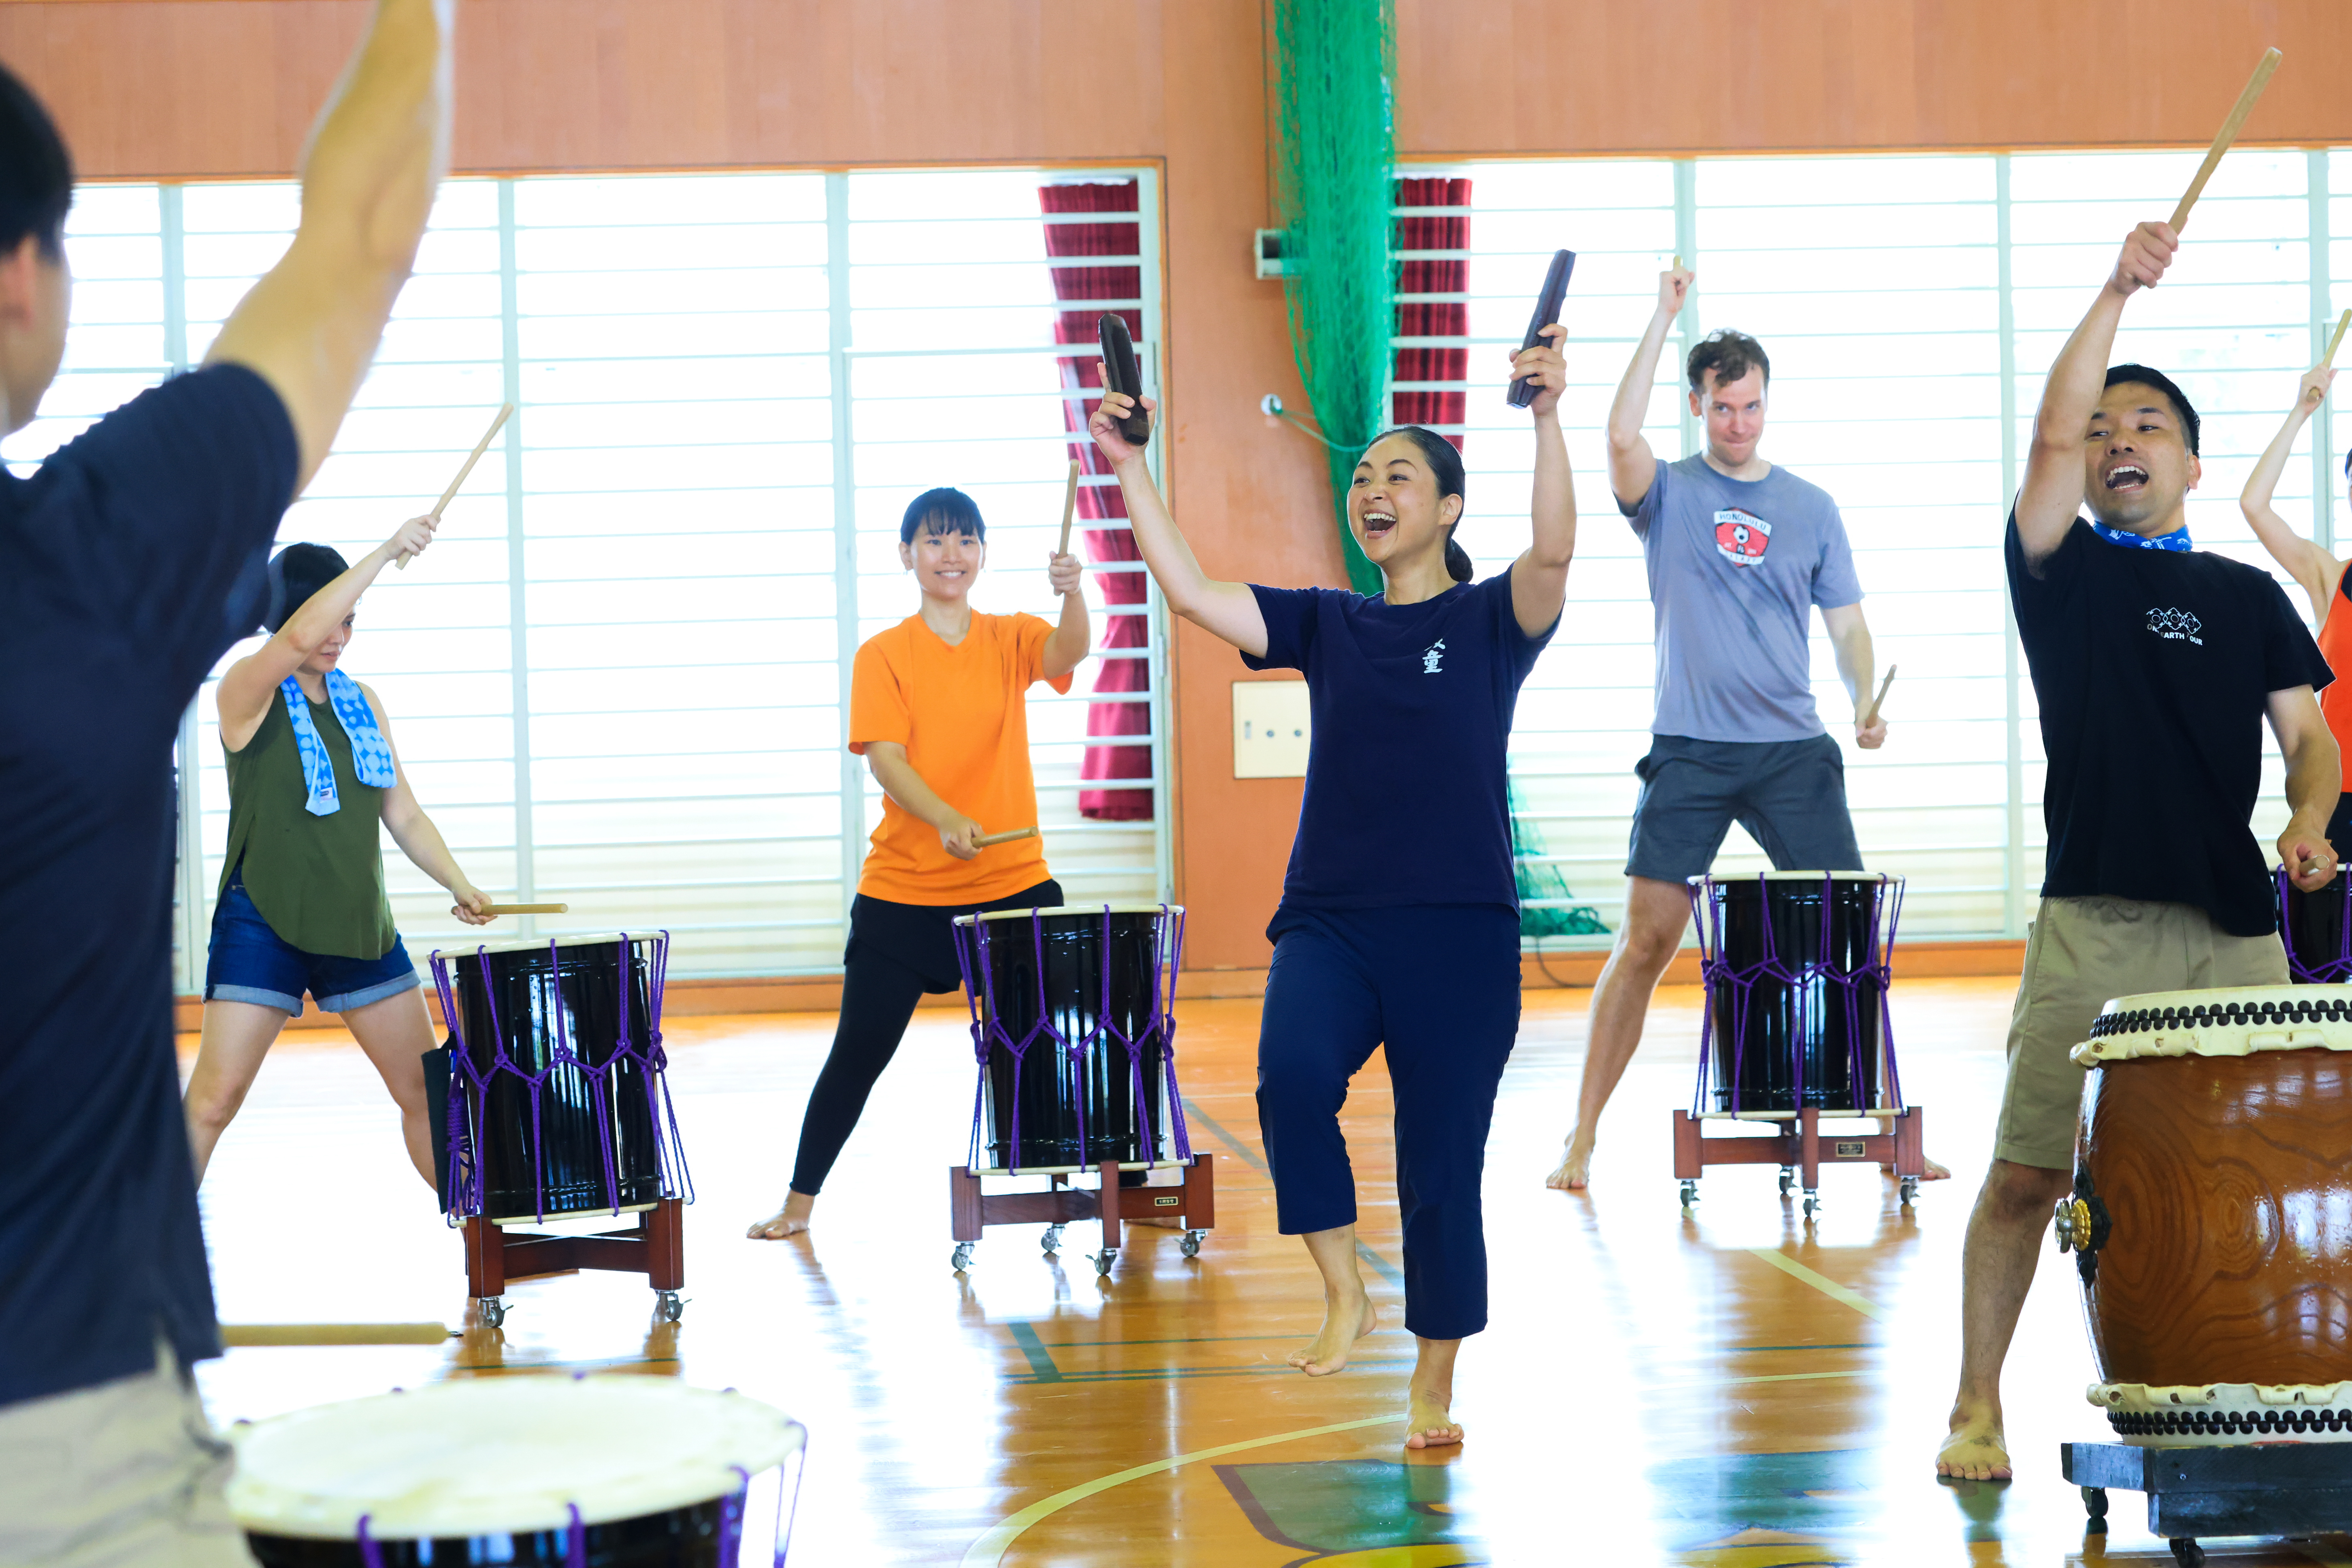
[1242,571,1559,910]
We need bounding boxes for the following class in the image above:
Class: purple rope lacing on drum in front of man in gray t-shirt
[1686,872,1903,1116]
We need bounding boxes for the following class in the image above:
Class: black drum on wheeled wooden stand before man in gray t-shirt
[1675,872,1926,1220]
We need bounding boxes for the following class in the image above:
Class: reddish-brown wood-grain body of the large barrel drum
[2077,1048,2352,1385]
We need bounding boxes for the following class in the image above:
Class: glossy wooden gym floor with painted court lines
[183,980,2352,1568]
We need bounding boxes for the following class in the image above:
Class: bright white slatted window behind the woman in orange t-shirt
[0,169,1171,990]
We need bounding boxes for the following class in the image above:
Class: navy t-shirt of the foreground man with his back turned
[0,367,299,1406]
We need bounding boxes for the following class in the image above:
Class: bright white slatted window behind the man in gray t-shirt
[1404,151,2352,945]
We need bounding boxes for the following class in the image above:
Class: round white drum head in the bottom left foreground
[228,1375,802,1540]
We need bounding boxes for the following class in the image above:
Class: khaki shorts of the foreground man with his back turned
[0,1347,254,1568]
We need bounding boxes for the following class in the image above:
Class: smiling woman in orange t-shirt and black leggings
[748,489,1091,1241]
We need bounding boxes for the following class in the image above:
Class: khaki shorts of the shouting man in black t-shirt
[1992,898,2286,1171]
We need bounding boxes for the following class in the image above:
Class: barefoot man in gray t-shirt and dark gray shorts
[1550,266,1900,1187]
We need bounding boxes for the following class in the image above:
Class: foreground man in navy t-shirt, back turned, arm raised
[0,0,452,1568]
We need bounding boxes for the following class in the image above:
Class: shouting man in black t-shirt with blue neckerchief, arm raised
[1936,223,2340,1481]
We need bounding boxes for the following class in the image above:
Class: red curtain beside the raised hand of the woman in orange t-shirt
[1037,179,1152,823]
